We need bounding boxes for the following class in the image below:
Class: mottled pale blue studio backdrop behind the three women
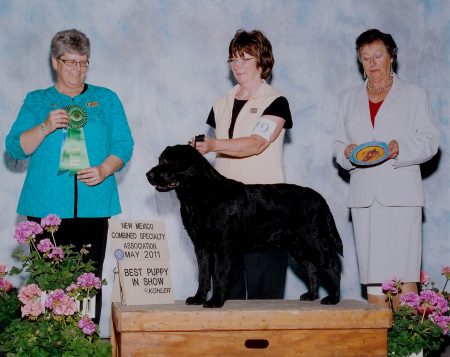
[0,0,450,336]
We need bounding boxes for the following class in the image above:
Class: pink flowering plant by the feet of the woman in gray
[382,266,450,356]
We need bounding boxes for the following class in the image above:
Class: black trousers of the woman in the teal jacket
[28,217,108,323]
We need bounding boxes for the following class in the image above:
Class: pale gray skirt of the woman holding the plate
[351,201,422,284]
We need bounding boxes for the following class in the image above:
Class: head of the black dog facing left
[146,145,206,192]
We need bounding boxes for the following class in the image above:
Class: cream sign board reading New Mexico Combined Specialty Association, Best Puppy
[108,219,174,305]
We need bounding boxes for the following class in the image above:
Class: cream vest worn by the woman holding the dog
[213,83,286,184]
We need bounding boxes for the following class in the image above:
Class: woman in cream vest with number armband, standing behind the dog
[192,30,292,299]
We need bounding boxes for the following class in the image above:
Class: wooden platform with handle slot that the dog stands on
[111,300,392,357]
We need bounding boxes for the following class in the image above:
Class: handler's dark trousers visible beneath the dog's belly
[228,250,288,300]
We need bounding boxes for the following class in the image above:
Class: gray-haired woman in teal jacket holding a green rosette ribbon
[6,29,133,318]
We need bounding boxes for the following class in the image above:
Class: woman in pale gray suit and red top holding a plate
[333,29,439,306]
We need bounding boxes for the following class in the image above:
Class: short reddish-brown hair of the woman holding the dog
[228,29,275,79]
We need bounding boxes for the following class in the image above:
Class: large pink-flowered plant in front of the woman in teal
[0,214,111,356]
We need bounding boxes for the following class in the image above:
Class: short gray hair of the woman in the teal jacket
[50,29,91,58]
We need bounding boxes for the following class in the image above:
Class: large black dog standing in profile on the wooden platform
[147,145,343,307]
